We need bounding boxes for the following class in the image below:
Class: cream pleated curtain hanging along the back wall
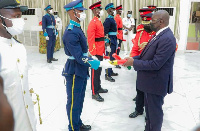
[21,0,180,38]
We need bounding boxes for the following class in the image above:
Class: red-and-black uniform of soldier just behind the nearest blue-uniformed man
[87,1,107,101]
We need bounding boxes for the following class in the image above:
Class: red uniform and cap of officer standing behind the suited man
[129,8,156,118]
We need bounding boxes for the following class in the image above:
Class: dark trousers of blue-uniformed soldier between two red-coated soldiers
[106,44,117,77]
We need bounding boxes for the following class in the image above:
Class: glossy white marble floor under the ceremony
[26,47,200,131]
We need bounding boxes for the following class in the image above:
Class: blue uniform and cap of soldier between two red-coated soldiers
[103,3,118,77]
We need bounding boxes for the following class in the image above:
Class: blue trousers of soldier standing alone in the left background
[47,35,56,60]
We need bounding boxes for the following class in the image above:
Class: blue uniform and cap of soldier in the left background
[42,5,57,60]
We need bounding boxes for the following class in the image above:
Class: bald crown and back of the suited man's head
[153,10,169,26]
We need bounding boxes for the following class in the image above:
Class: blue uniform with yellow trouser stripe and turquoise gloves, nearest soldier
[62,0,100,131]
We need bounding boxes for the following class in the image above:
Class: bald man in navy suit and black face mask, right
[124,10,176,131]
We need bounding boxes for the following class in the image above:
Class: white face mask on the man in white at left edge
[1,16,25,36]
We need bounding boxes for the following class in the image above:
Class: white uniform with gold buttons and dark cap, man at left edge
[0,0,36,131]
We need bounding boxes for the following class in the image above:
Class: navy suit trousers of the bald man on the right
[144,92,164,131]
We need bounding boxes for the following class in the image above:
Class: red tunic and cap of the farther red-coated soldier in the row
[115,5,123,55]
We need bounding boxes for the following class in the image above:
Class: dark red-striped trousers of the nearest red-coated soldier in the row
[91,55,103,95]
